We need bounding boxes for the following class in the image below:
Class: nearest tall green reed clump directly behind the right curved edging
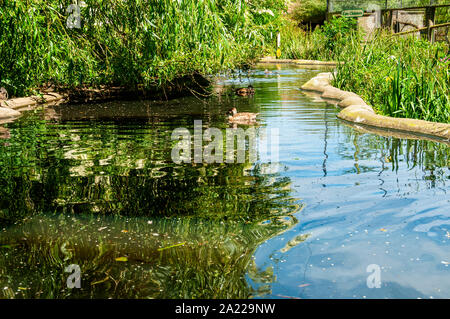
[335,33,450,123]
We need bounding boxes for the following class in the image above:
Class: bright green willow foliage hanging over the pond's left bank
[0,0,285,96]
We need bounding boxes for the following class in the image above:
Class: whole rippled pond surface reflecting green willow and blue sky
[0,65,450,298]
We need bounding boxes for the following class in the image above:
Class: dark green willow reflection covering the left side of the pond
[0,87,302,298]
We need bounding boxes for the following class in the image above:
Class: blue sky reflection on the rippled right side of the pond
[248,64,450,298]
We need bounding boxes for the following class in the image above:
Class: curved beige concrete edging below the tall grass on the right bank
[301,72,450,141]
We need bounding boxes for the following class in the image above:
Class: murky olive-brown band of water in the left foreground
[0,211,298,299]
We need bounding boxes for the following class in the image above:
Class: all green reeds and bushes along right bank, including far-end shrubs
[282,18,450,123]
